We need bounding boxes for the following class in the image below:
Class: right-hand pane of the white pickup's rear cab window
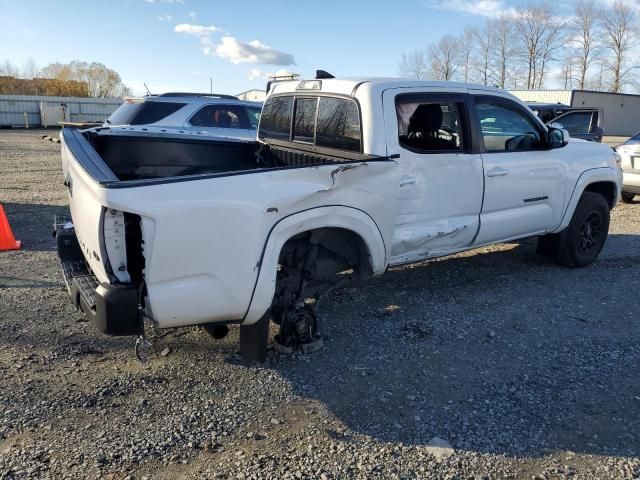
[316,97,360,152]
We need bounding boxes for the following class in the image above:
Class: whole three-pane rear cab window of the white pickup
[258,95,362,152]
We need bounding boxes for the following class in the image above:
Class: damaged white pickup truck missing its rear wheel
[56,79,622,359]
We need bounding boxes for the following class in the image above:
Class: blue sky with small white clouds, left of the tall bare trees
[0,0,568,94]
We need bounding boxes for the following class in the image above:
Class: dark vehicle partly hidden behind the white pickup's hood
[527,102,604,143]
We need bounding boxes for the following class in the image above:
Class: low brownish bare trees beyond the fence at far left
[0,58,131,98]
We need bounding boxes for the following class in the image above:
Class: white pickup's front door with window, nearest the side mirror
[474,95,566,245]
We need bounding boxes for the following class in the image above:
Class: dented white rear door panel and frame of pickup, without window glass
[383,88,483,264]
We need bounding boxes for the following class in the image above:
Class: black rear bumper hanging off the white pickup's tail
[54,216,142,335]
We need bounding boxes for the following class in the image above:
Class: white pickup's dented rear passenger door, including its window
[383,88,483,264]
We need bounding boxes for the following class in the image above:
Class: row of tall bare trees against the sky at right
[398,0,640,93]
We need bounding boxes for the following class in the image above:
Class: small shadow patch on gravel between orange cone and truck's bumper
[2,203,69,251]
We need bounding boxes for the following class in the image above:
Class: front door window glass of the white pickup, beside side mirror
[476,97,544,152]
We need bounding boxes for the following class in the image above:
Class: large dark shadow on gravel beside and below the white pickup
[274,235,640,457]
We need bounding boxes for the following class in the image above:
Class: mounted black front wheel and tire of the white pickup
[554,192,609,268]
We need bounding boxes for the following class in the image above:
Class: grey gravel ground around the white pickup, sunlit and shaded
[0,130,640,479]
